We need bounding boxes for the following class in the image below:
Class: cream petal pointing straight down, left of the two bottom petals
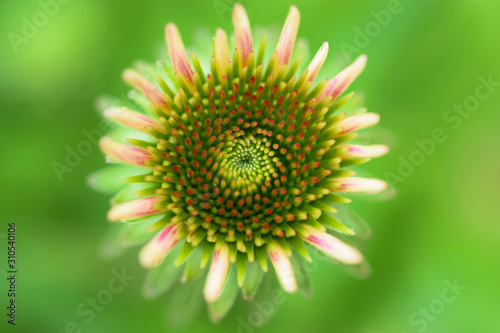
[203,243,229,303]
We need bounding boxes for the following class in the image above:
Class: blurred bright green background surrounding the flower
[0,0,500,333]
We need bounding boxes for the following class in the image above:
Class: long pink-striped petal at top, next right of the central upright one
[275,6,300,68]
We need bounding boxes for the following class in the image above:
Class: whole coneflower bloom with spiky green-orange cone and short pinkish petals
[91,4,388,320]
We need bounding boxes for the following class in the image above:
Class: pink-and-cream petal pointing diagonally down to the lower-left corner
[139,222,184,268]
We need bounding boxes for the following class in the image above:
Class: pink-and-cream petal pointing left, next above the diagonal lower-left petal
[108,196,165,222]
